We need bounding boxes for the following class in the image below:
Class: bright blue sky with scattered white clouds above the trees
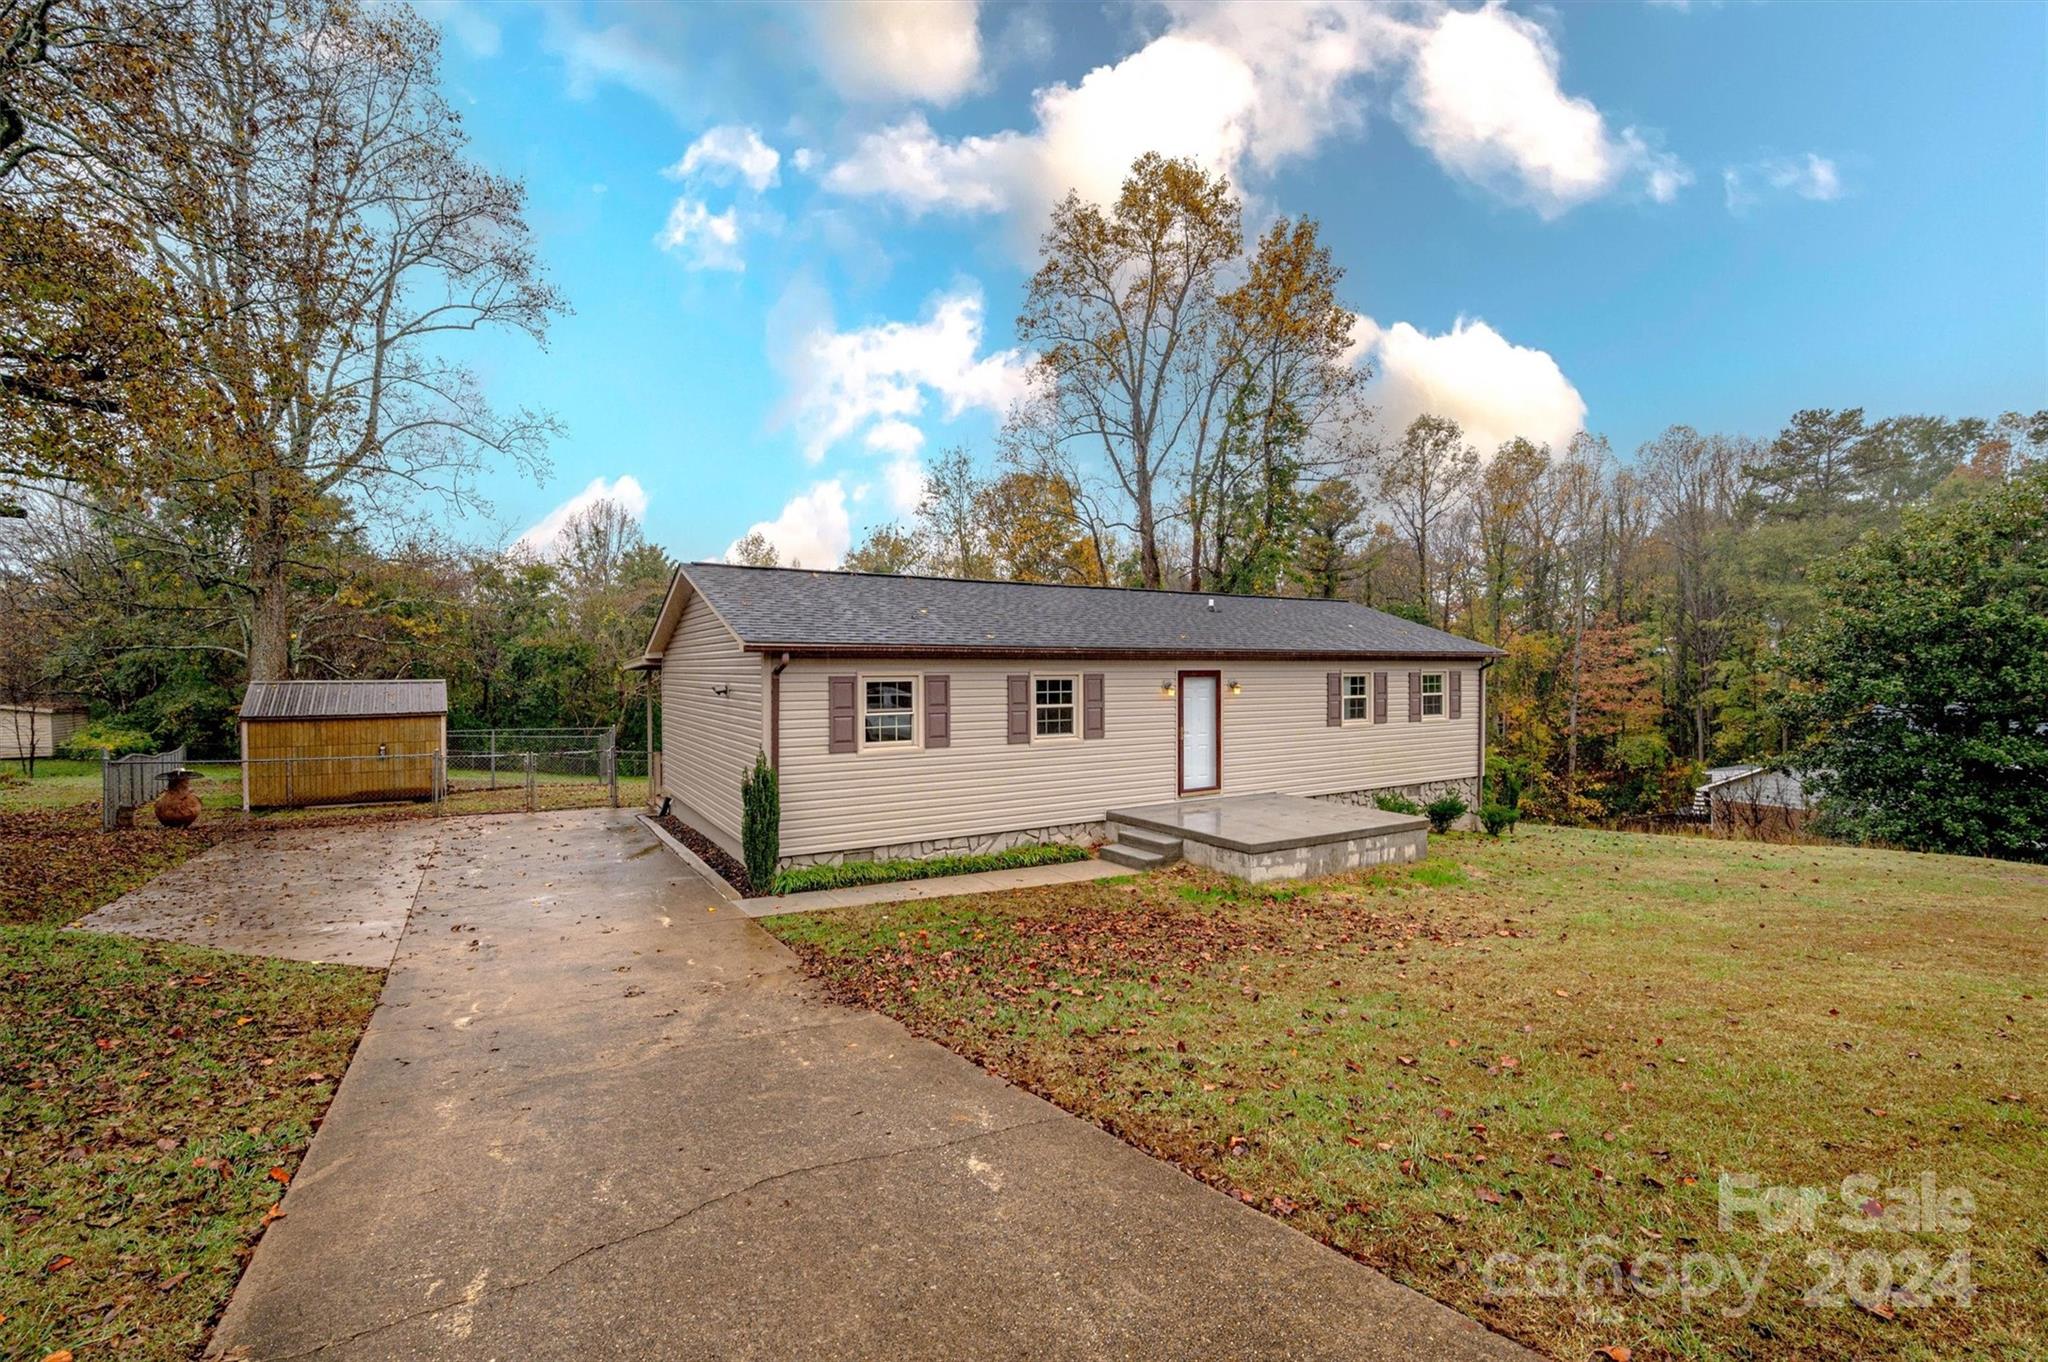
[422,0,2048,565]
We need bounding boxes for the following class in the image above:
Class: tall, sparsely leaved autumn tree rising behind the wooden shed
[34,0,563,680]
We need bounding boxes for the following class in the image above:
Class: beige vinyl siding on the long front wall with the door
[782,659,1479,856]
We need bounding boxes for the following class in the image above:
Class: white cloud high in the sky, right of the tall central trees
[1405,4,1692,217]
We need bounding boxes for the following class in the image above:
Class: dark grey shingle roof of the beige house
[682,563,1497,657]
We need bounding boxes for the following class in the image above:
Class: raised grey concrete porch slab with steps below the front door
[1108,795,1430,883]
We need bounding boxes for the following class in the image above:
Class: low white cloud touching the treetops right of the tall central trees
[1352,317,1585,455]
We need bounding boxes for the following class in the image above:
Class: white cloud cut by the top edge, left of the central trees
[811,0,981,104]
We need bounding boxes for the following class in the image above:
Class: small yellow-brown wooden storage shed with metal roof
[242,680,449,809]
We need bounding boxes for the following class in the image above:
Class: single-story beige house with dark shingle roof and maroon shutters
[637,563,1499,864]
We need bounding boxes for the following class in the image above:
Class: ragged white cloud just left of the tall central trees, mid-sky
[786,287,1028,463]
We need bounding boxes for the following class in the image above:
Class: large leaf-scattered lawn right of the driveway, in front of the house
[766,827,2048,1362]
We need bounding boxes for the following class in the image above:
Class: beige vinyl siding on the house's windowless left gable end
[662,592,765,846]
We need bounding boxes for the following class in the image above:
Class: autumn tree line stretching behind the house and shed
[0,0,2048,844]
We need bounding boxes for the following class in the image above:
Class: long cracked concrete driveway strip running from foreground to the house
[213,811,1532,1362]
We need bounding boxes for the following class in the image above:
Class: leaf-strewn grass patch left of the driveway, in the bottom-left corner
[0,926,383,1362]
